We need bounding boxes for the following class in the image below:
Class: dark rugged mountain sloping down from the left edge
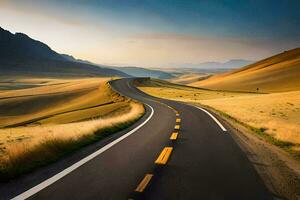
[0,27,128,77]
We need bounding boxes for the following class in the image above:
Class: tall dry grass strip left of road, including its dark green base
[0,102,144,180]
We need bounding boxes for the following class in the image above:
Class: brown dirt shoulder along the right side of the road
[200,104,300,199]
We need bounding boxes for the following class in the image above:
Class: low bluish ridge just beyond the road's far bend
[113,67,174,79]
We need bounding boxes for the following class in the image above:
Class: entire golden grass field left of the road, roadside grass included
[0,78,144,178]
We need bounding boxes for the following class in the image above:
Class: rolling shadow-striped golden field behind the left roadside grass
[0,78,124,127]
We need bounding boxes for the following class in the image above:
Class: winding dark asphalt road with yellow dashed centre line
[0,79,272,200]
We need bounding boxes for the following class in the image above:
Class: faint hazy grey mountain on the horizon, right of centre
[176,59,254,69]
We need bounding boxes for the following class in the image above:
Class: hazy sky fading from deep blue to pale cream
[0,0,300,67]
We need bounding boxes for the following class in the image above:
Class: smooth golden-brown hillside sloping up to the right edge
[191,48,300,92]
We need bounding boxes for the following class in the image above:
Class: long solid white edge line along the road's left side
[12,104,154,200]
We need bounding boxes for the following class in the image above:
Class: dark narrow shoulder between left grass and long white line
[0,104,152,199]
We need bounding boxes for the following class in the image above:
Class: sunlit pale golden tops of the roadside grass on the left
[0,102,144,160]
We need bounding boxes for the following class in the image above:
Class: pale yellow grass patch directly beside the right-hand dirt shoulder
[200,91,300,144]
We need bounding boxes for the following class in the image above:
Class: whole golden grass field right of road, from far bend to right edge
[139,80,300,151]
